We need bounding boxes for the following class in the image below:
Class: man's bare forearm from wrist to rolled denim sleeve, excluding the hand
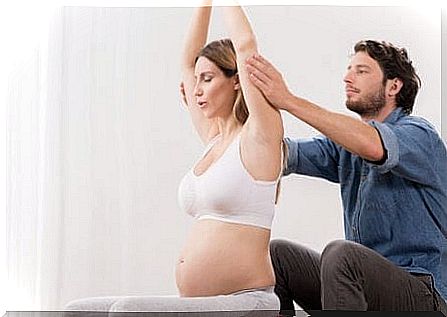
[281,96,384,161]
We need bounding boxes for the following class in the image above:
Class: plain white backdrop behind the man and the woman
[6,6,441,310]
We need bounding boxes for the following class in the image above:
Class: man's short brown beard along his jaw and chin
[346,85,385,118]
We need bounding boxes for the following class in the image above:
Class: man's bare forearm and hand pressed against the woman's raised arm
[246,55,385,162]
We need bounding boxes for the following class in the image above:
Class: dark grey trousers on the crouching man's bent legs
[270,240,447,315]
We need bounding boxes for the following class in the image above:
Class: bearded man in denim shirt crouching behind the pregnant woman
[246,40,447,314]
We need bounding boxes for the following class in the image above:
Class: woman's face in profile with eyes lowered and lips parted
[194,56,239,119]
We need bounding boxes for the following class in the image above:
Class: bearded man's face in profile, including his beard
[343,52,386,118]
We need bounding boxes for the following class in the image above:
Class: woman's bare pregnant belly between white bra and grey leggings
[176,220,275,297]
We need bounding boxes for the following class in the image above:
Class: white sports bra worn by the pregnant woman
[178,133,279,229]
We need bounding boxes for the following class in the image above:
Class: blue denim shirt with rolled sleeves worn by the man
[284,108,447,299]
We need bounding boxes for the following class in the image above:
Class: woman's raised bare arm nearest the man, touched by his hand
[224,6,284,180]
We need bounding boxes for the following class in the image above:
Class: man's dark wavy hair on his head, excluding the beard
[354,40,421,114]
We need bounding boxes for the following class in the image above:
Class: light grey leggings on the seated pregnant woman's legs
[65,286,279,313]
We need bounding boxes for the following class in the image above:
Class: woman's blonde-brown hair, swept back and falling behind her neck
[196,39,248,124]
